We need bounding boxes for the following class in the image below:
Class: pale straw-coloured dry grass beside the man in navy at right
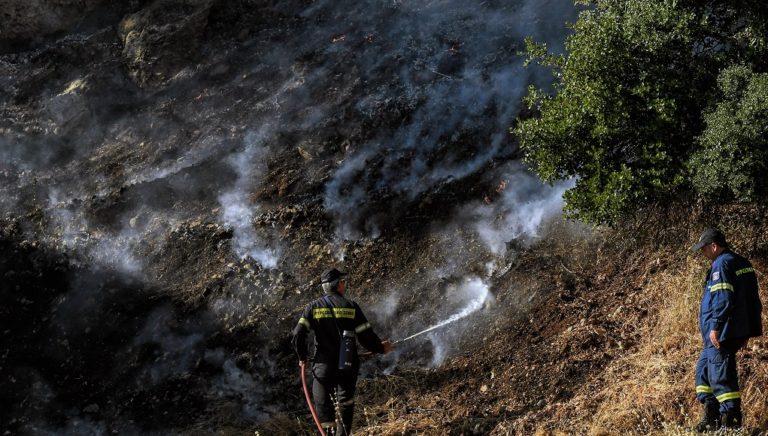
[589,257,768,435]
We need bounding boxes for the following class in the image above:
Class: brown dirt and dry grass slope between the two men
[344,207,768,435]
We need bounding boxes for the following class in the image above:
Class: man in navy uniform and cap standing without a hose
[691,228,762,432]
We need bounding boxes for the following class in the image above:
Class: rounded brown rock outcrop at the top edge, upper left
[118,0,213,88]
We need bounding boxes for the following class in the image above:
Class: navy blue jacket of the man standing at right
[699,249,763,343]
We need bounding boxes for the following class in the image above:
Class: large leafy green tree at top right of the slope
[513,0,768,223]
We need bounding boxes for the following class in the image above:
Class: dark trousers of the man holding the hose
[312,363,357,436]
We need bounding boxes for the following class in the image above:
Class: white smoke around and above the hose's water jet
[366,162,572,372]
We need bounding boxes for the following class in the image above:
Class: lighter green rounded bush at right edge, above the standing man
[690,65,768,201]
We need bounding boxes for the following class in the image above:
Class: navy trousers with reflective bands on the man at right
[696,339,744,413]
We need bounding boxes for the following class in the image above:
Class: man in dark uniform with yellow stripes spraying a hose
[293,268,392,436]
